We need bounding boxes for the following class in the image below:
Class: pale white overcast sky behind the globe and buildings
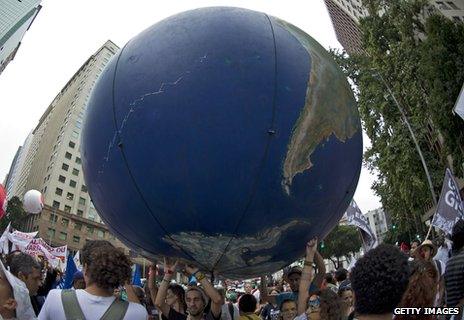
[0,0,380,212]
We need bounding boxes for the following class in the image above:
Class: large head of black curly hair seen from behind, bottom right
[351,244,409,320]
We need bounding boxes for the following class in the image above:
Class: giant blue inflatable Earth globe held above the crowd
[81,7,362,278]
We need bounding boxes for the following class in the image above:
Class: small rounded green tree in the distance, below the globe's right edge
[320,225,362,269]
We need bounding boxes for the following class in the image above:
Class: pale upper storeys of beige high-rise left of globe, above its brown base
[22,41,119,221]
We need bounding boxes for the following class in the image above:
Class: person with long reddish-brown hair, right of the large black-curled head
[395,260,439,320]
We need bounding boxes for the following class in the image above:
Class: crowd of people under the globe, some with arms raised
[0,220,464,320]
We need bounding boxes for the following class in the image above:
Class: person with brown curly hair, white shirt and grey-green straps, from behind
[39,240,148,320]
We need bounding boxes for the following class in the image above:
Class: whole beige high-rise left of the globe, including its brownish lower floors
[10,41,142,252]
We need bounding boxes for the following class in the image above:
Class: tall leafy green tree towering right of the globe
[334,0,464,240]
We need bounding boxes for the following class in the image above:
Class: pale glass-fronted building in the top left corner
[0,0,42,73]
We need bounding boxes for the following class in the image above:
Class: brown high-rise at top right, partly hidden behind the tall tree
[324,0,464,53]
